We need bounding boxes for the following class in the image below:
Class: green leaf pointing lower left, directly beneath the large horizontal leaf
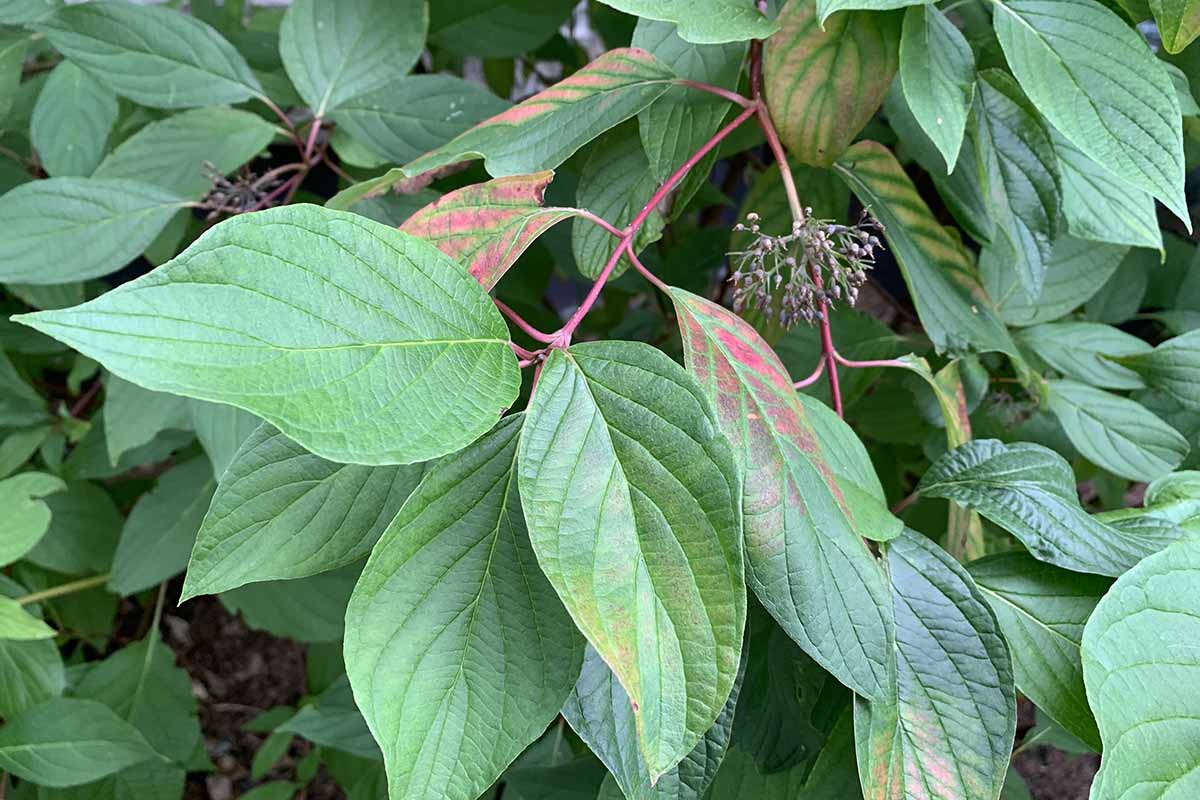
[181,425,422,600]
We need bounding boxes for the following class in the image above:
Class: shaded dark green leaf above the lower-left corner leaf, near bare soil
[74,630,200,764]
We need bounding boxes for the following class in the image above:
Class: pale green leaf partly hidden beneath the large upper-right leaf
[1052,131,1163,249]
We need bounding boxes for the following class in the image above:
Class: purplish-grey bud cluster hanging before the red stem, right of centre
[730,209,883,327]
